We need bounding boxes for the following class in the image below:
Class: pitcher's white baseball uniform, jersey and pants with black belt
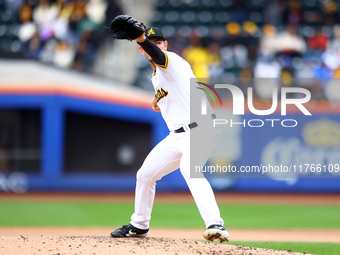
[130,51,224,229]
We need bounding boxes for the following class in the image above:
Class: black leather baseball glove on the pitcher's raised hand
[110,15,146,41]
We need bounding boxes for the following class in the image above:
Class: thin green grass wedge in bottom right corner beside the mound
[228,242,340,255]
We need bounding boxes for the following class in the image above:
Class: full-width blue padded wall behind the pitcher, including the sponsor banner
[0,94,340,192]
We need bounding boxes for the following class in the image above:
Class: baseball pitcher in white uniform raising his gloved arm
[110,15,229,242]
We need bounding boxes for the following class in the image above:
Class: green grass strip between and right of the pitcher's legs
[152,204,340,229]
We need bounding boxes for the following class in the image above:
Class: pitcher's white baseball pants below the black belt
[130,122,224,229]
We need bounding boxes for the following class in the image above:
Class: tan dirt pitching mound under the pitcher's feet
[0,235,308,255]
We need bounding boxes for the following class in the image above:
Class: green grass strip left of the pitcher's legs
[0,202,133,227]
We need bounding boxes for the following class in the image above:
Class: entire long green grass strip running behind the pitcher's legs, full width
[0,201,340,229]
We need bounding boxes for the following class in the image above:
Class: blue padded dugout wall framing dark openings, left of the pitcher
[0,95,181,191]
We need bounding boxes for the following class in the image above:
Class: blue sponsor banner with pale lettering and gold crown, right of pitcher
[237,114,340,178]
